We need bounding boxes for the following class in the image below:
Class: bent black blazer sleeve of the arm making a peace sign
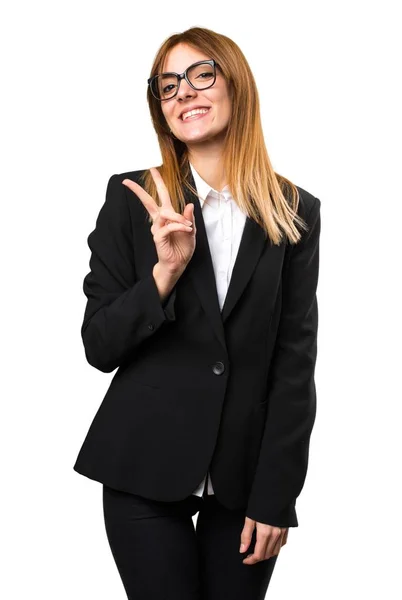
[81,175,176,373]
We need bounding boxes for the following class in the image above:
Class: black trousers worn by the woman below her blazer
[103,485,278,600]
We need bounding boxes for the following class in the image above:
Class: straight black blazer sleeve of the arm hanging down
[246,198,321,527]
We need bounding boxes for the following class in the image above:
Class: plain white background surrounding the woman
[0,0,402,600]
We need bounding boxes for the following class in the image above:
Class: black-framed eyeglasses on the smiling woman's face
[148,59,219,101]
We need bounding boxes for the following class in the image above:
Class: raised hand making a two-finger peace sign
[122,168,196,275]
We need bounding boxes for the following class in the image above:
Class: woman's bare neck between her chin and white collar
[187,137,226,192]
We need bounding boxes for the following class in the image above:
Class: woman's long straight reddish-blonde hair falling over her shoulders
[141,27,307,245]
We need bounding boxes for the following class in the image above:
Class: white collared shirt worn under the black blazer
[190,163,247,496]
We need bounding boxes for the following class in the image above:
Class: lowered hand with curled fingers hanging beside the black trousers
[240,517,289,565]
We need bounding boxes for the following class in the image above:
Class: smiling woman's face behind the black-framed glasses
[161,44,231,146]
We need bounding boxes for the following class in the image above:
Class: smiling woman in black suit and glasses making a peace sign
[74,27,320,600]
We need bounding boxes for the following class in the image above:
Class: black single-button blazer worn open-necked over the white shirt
[74,166,321,527]
